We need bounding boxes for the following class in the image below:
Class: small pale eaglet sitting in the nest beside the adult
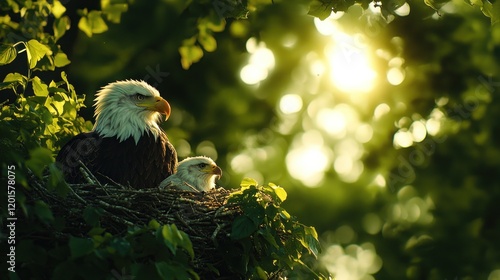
[159,156,222,192]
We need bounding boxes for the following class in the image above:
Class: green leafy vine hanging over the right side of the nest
[222,178,326,279]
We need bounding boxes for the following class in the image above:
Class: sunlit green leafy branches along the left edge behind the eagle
[0,1,91,188]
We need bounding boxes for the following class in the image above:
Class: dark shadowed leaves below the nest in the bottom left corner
[1,201,199,279]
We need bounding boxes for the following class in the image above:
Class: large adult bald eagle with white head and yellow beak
[56,80,177,188]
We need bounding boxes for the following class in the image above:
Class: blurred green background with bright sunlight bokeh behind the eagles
[46,0,500,280]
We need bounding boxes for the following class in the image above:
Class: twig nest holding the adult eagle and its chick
[29,175,242,279]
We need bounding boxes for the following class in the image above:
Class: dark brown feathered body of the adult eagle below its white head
[56,132,177,188]
